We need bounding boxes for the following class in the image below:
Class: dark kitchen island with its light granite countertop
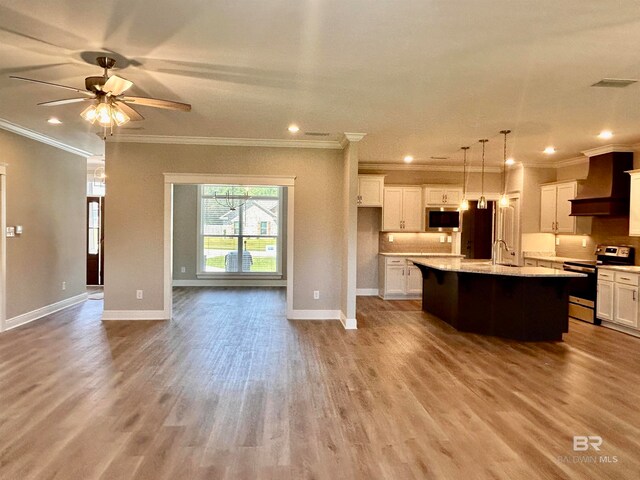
[409,258,584,341]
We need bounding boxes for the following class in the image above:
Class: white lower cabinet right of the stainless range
[596,269,640,329]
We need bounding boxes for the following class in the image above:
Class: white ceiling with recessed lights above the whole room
[0,0,640,163]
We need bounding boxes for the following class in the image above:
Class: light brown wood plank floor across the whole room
[0,288,640,480]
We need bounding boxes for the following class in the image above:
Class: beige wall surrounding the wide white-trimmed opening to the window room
[105,143,344,310]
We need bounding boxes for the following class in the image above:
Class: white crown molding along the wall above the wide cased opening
[107,134,343,150]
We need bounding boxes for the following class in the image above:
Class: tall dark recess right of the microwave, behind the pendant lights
[460,200,496,259]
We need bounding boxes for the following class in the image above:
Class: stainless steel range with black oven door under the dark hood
[563,245,635,325]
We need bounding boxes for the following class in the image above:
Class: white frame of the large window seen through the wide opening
[196,184,285,280]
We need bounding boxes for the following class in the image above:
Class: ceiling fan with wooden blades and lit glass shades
[11,57,191,139]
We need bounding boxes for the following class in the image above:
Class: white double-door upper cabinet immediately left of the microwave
[382,187,422,232]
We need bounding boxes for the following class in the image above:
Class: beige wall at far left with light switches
[0,130,87,319]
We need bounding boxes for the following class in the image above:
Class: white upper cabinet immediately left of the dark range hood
[540,182,578,233]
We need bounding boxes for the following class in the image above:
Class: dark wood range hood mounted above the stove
[571,145,633,217]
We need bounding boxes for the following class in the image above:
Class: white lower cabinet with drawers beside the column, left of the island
[379,256,422,300]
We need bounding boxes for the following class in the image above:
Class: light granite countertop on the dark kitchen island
[409,258,586,278]
